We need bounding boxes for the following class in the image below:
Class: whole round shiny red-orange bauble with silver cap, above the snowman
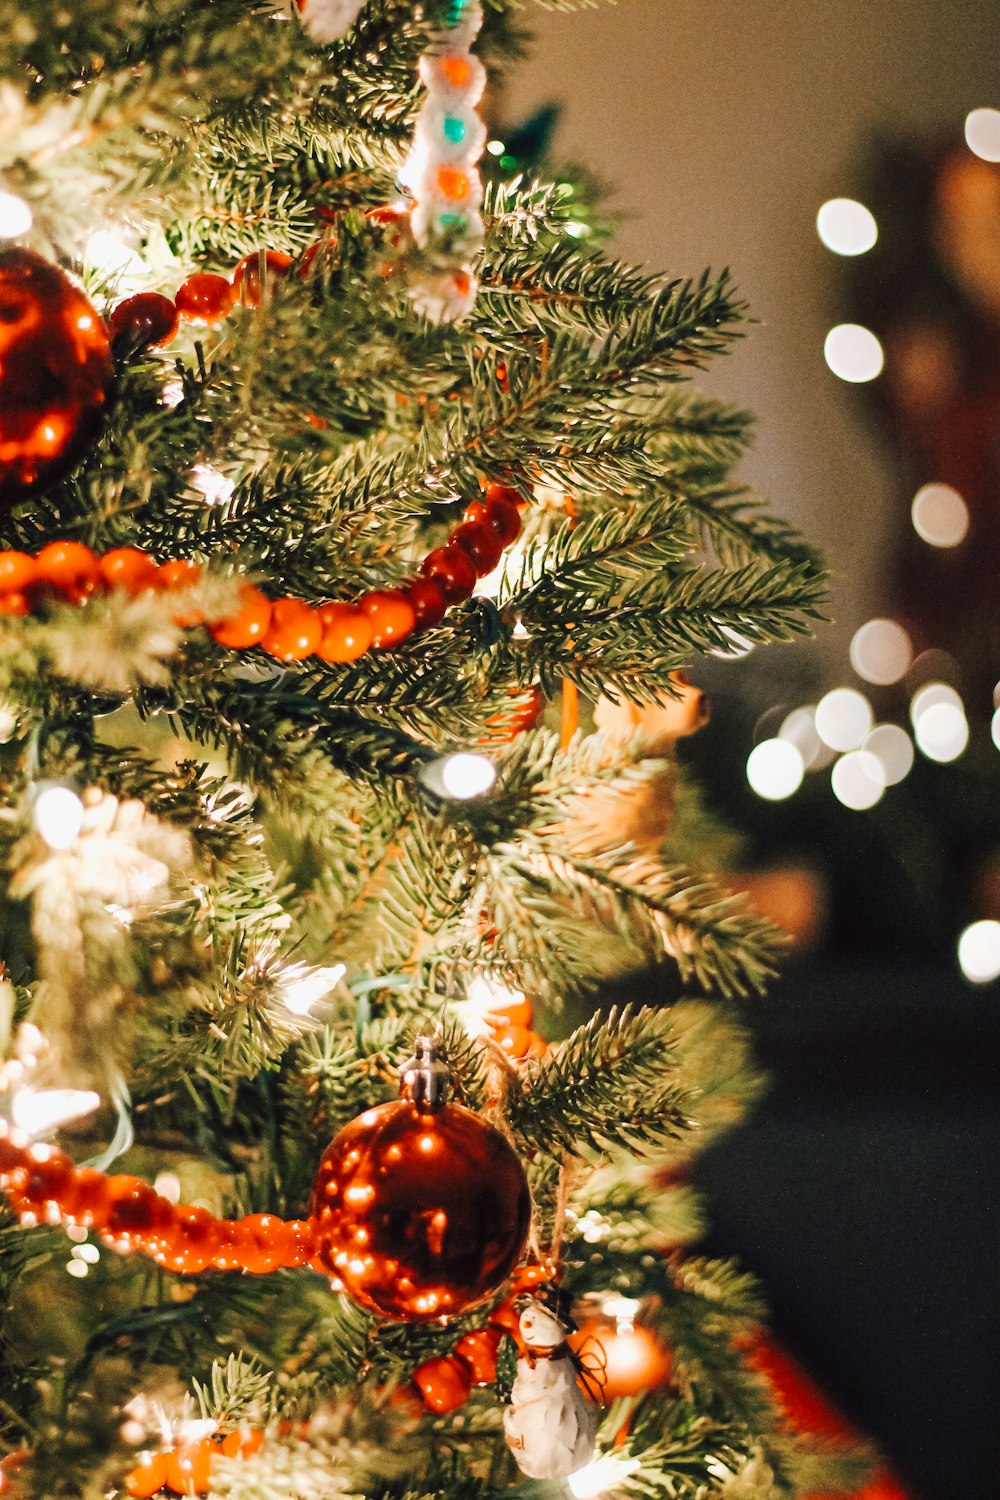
[312,1100,529,1323]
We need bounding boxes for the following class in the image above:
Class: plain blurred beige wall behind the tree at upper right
[505,0,1000,677]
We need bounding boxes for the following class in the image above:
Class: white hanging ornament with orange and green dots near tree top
[400,0,486,323]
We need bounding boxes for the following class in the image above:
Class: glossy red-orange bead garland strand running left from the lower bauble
[0,1121,313,1275]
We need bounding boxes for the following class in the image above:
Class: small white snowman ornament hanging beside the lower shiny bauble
[504,1284,601,1479]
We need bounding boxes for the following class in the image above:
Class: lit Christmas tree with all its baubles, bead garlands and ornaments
[0,0,859,1500]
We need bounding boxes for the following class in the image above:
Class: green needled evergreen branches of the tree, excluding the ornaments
[0,0,855,1500]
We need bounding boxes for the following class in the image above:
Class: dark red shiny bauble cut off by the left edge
[0,248,114,503]
